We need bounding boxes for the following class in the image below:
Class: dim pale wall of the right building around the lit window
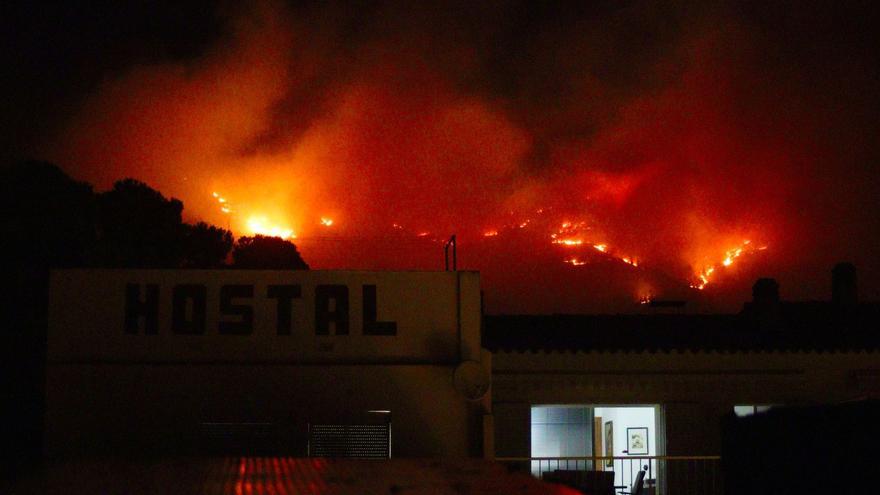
[493,352,880,456]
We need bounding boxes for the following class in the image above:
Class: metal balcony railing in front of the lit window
[495,456,724,495]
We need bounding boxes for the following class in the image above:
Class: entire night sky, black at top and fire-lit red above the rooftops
[0,1,880,312]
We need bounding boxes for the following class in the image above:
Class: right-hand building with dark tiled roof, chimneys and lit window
[483,265,880,495]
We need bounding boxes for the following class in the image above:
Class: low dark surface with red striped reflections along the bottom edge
[0,457,578,495]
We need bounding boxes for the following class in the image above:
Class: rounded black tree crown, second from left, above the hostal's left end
[96,179,184,268]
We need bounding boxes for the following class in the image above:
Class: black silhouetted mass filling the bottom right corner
[722,401,880,495]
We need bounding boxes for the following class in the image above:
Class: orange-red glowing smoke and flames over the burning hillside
[50,3,876,310]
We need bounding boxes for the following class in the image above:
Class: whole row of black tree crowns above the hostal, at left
[0,161,308,270]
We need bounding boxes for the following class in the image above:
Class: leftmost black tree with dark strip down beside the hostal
[0,161,95,477]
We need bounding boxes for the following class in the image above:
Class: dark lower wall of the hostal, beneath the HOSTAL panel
[46,364,481,457]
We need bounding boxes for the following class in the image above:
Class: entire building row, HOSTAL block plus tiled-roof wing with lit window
[8,269,880,495]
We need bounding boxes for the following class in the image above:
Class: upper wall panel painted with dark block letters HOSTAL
[49,270,479,362]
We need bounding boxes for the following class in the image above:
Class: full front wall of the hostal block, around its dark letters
[45,270,491,457]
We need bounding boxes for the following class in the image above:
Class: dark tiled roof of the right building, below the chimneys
[483,302,880,352]
